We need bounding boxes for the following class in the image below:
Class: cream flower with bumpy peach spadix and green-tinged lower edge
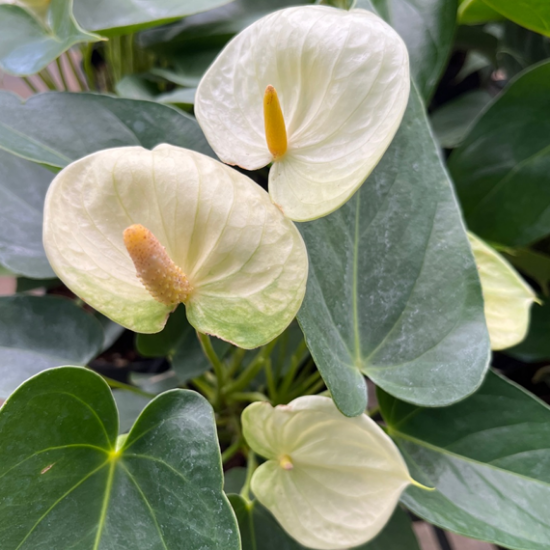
[44,145,307,348]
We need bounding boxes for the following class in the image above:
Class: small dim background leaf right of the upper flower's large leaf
[430,90,491,149]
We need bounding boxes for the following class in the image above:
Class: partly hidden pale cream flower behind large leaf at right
[468,233,537,350]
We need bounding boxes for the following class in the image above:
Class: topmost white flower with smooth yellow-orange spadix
[195,6,410,221]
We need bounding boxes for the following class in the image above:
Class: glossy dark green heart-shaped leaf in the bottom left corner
[0,367,240,550]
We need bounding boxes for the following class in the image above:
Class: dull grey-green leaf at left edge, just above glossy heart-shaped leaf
[0,295,103,397]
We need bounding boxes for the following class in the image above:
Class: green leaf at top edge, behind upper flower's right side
[370,0,457,100]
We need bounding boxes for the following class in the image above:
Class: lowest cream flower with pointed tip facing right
[242,395,417,550]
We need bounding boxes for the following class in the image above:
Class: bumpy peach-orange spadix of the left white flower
[123,224,191,306]
